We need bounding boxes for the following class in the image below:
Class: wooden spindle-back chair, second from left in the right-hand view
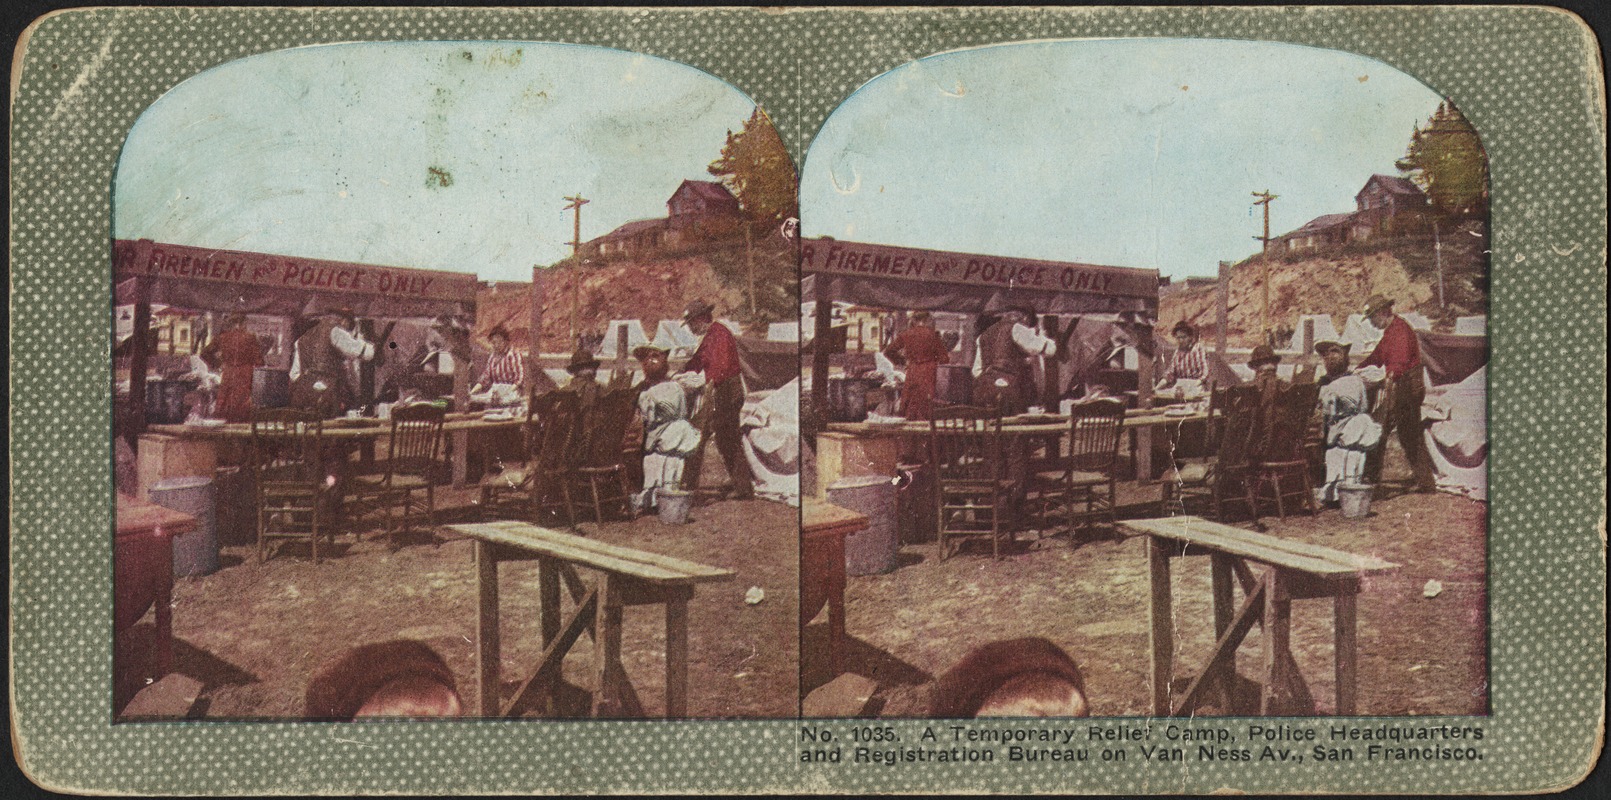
[1025,399,1124,536]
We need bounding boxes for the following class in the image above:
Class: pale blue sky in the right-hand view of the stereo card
[801,39,1440,277]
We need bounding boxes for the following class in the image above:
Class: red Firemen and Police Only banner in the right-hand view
[801,238,1158,299]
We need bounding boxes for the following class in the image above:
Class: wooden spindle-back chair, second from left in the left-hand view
[346,406,446,542]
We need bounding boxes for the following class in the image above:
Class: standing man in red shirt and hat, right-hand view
[1360,295,1437,493]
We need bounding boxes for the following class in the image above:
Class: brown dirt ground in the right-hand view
[804,466,1489,716]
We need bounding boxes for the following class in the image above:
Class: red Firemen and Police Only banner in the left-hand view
[113,238,480,303]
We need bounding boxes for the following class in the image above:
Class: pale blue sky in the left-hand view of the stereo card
[113,42,754,280]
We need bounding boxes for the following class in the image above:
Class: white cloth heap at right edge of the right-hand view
[1421,367,1489,501]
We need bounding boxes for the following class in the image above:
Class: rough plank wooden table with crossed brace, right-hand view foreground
[1118,517,1398,716]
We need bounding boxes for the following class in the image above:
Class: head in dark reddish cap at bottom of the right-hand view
[930,636,1091,720]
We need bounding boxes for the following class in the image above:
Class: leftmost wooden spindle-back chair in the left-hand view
[248,409,335,563]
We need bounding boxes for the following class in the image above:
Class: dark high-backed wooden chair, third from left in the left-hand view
[482,391,582,525]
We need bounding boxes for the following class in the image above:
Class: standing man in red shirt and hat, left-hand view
[683,301,756,501]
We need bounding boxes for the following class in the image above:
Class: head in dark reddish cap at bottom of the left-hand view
[303,639,464,721]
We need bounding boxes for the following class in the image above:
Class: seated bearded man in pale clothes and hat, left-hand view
[632,344,699,512]
